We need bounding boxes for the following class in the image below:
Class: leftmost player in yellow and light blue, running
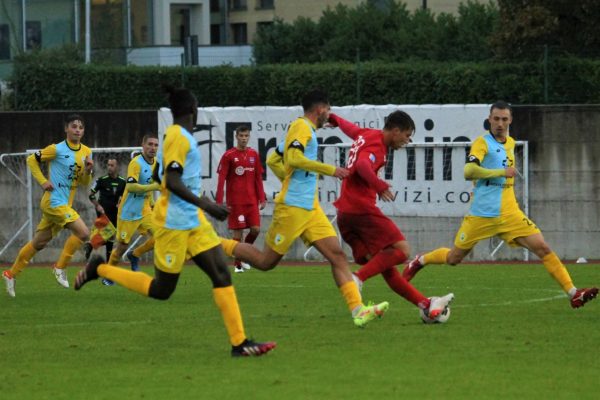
[2,114,94,297]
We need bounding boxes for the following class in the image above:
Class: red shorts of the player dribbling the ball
[337,211,406,265]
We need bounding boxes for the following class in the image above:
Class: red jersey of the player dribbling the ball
[329,114,390,214]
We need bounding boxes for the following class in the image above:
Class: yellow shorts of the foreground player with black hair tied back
[154,214,221,274]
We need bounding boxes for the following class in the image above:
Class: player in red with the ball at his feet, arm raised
[329,110,454,319]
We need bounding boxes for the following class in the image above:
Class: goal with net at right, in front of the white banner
[305,141,529,261]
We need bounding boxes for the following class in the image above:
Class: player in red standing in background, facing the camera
[216,125,267,272]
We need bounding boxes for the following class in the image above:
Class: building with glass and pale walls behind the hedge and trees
[0,0,474,79]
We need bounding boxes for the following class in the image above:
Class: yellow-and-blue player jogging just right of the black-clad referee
[103,135,160,285]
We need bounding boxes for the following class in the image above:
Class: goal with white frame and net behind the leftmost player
[0,147,141,262]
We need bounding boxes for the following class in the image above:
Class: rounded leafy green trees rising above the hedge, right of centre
[254,0,499,64]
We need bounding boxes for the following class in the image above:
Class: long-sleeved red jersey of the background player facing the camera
[216,147,266,206]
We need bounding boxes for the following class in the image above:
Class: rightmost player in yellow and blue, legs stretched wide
[403,101,598,308]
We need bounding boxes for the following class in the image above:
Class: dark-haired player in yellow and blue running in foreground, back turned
[74,88,275,357]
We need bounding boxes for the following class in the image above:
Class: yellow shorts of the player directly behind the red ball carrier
[265,204,337,255]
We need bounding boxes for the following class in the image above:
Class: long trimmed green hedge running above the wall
[10,58,600,110]
